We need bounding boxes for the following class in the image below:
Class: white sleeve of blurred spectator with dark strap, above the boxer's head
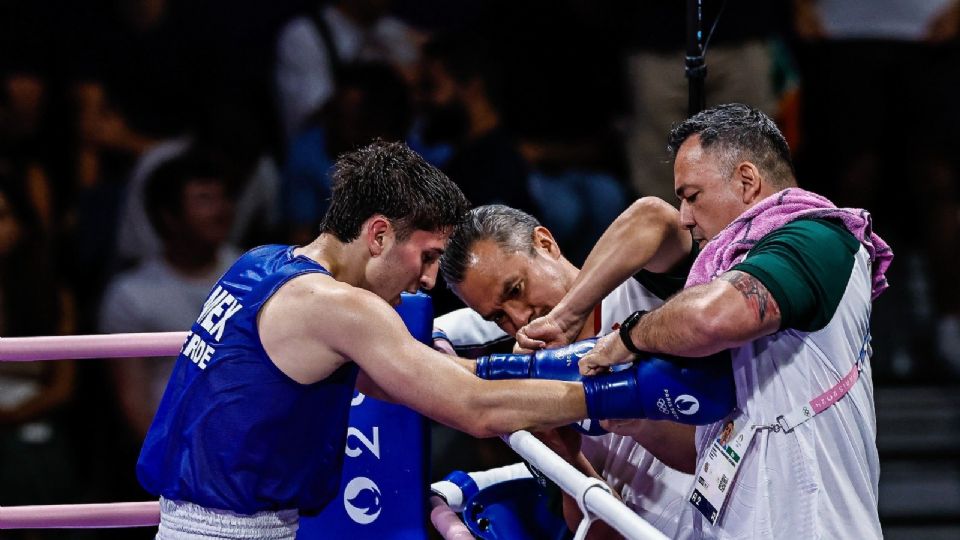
[276,17,334,141]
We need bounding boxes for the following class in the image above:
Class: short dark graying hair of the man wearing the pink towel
[667,103,796,187]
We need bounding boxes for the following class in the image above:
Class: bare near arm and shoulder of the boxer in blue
[260,275,587,437]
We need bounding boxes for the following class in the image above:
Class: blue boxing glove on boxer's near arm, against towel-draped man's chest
[583,351,737,426]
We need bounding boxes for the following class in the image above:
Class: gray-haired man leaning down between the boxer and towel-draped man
[434,198,694,537]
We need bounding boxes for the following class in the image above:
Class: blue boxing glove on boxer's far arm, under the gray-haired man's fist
[477,338,597,382]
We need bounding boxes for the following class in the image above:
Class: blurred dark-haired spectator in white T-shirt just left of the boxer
[100,150,239,440]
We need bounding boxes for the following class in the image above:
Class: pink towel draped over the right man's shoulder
[686,188,893,299]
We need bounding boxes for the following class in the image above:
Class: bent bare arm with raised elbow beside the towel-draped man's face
[517,197,692,349]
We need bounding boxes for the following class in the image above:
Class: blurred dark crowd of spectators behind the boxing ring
[0,0,960,534]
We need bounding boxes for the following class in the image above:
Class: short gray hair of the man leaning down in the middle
[440,204,540,286]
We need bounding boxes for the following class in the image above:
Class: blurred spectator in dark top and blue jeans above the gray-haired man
[480,0,628,262]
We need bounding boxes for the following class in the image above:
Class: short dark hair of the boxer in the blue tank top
[320,140,470,242]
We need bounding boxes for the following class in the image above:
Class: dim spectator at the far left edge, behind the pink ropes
[0,176,78,516]
